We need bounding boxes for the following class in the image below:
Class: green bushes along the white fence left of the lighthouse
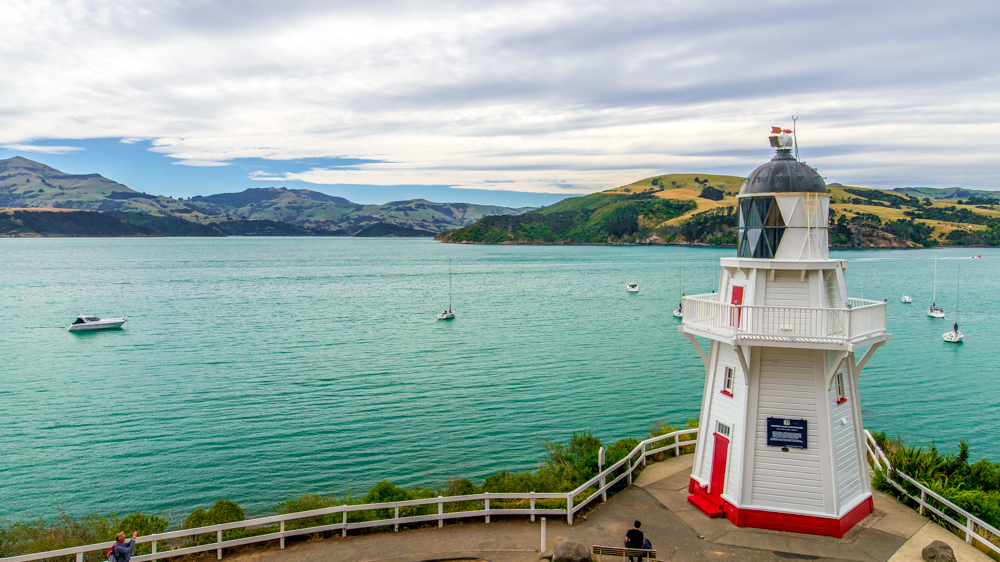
[0,419,698,562]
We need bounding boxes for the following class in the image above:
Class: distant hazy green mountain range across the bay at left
[0,157,521,234]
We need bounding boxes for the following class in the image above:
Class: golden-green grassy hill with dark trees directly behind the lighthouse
[437,174,1000,248]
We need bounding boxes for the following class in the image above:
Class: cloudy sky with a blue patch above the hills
[0,0,1000,204]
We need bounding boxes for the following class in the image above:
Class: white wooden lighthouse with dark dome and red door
[681,129,890,537]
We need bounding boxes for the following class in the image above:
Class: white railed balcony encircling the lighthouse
[681,294,888,350]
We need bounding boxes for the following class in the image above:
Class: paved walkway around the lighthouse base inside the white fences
[225,455,991,562]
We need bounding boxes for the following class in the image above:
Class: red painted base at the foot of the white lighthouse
[688,478,875,539]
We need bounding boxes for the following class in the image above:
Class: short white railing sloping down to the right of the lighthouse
[865,429,1000,556]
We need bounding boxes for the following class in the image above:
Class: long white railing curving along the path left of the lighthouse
[0,428,698,562]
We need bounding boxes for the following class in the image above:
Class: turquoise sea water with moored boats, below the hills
[0,238,1000,519]
